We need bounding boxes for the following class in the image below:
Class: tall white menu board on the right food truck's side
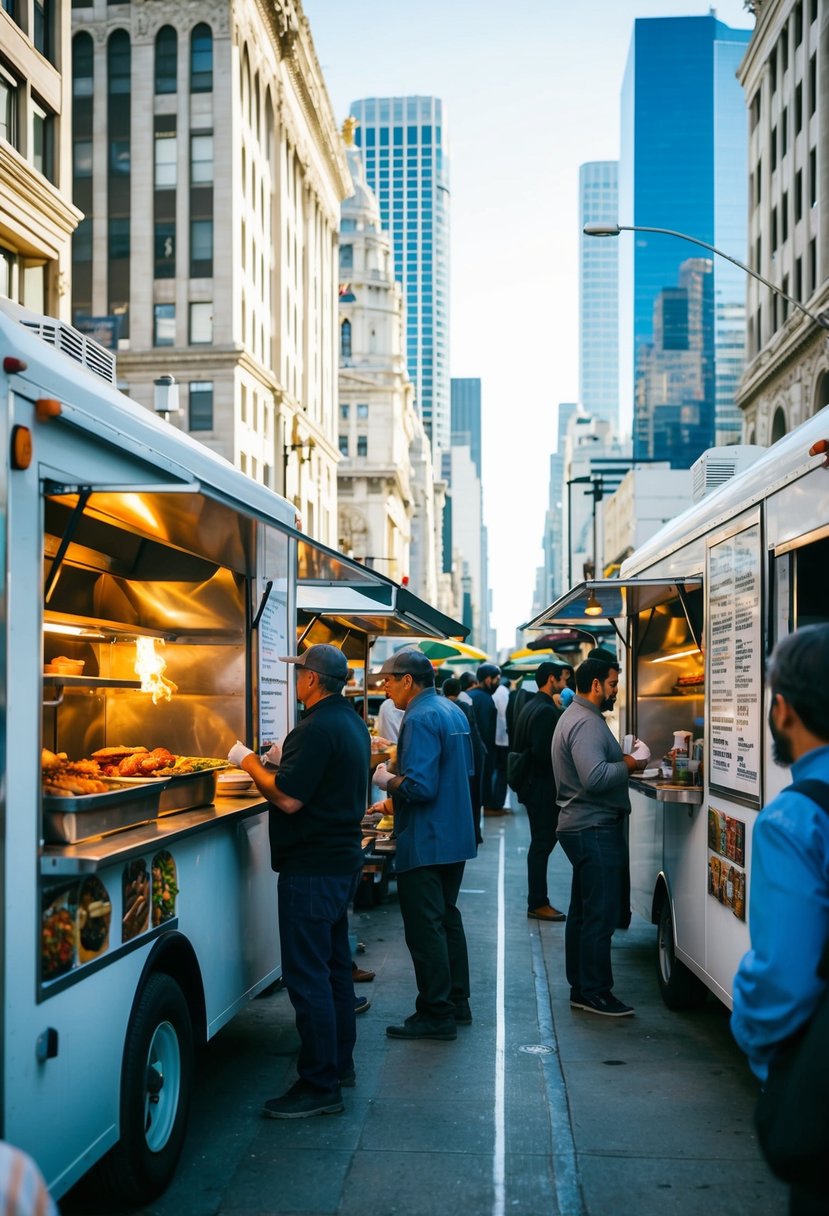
[706,524,762,801]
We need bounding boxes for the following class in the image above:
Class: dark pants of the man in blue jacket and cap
[397,861,469,1020]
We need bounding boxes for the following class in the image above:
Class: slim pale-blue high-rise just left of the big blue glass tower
[579,161,619,429]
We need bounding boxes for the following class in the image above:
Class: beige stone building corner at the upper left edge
[0,0,80,321]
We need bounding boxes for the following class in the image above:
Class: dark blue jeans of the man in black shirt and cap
[277,871,360,1090]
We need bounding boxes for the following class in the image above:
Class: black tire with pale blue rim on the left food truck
[95,972,193,1206]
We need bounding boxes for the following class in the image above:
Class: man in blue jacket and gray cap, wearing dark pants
[374,651,476,1041]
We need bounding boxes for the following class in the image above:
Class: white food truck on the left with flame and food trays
[0,305,466,1204]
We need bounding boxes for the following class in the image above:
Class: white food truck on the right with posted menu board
[528,410,829,1008]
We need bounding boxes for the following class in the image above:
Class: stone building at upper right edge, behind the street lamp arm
[738,0,829,444]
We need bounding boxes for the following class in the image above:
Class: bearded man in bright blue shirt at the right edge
[731,625,829,1216]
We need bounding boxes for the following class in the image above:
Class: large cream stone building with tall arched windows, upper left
[66,0,350,545]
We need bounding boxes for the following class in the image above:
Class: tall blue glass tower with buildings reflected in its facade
[619,16,751,468]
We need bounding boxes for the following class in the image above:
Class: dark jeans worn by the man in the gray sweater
[558,822,627,996]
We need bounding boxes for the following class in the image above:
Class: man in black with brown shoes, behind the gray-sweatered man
[513,660,569,922]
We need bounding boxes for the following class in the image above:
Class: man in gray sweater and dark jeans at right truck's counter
[552,659,644,1018]
